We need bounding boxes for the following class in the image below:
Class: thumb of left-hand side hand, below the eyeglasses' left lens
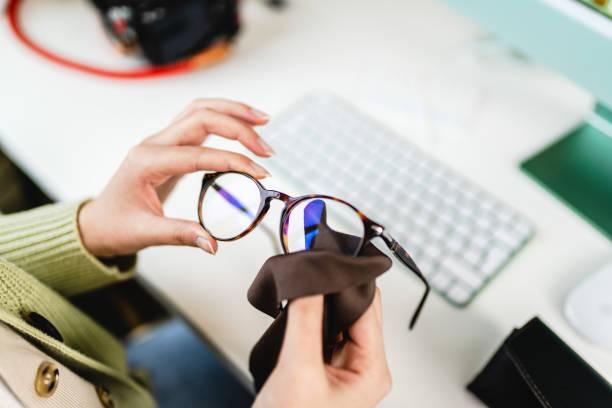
[149,217,217,255]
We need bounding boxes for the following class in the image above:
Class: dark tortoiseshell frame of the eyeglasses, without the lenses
[198,171,429,329]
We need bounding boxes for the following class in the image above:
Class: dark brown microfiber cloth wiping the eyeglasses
[247,222,391,392]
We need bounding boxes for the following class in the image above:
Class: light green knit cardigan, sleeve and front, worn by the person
[0,203,155,407]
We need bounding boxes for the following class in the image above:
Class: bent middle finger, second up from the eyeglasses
[143,100,274,157]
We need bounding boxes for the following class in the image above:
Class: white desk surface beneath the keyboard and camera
[0,0,612,407]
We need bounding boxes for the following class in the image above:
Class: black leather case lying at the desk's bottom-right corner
[467,317,612,408]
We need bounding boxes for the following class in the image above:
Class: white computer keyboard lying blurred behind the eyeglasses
[262,95,533,306]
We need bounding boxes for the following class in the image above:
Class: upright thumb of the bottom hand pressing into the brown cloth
[280,295,323,367]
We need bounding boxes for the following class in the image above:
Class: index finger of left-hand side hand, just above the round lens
[126,145,269,182]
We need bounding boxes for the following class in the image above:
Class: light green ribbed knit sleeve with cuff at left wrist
[0,202,136,296]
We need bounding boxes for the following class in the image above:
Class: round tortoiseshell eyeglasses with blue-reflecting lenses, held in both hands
[198,171,429,329]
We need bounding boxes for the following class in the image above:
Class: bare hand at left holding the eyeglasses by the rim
[79,99,274,257]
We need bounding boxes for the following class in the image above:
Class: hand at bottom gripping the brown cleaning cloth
[253,289,391,408]
